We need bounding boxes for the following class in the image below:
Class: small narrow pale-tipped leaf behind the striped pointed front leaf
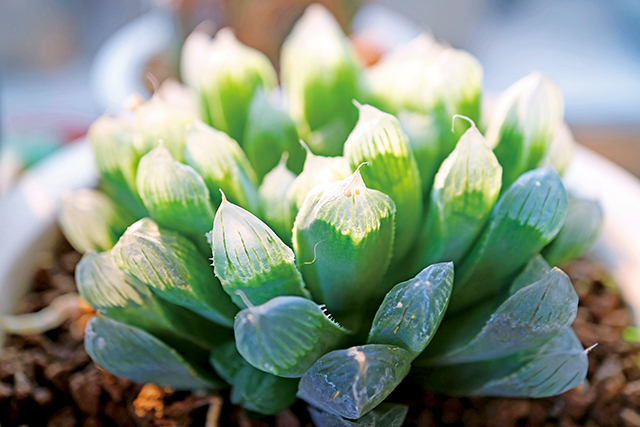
[258,154,296,244]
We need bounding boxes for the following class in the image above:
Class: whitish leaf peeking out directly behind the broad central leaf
[287,151,351,229]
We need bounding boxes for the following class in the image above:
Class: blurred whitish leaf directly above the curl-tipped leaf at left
[133,97,197,161]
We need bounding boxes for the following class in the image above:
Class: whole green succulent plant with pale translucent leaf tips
[60,5,602,427]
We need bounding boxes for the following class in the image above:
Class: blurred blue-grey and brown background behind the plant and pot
[0,0,640,194]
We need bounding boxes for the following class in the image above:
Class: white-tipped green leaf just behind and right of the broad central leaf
[344,105,422,260]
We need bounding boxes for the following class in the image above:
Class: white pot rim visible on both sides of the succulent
[0,140,640,324]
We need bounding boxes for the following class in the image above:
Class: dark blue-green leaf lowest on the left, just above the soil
[84,315,222,390]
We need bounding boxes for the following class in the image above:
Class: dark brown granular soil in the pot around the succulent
[0,232,640,427]
